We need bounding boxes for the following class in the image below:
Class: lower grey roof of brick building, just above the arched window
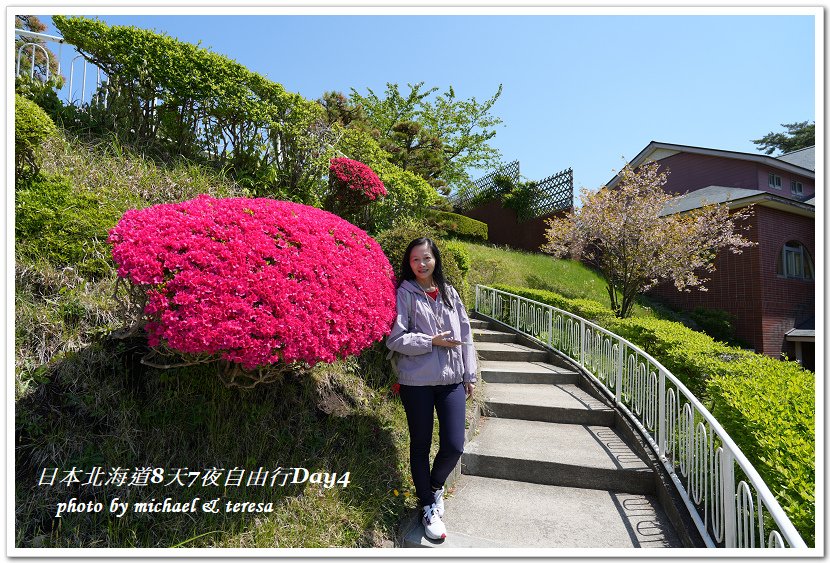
[660,186,815,216]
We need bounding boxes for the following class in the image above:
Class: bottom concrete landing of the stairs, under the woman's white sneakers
[405,475,683,549]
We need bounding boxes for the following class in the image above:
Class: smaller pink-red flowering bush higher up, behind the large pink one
[323,158,387,228]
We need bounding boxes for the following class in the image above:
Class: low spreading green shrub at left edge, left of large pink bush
[15,174,120,279]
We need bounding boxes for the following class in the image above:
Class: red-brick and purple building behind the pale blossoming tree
[608,142,816,370]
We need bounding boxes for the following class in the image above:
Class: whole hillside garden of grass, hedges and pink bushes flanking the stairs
[15,16,815,547]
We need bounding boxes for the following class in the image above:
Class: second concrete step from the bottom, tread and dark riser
[461,417,655,494]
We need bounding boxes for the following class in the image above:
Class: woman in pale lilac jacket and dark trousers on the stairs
[386,237,476,539]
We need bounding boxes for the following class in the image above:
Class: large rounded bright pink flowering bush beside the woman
[109,195,395,370]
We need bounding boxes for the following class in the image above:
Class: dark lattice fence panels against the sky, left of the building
[452,160,573,221]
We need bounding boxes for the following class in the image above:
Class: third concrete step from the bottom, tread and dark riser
[485,383,614,426]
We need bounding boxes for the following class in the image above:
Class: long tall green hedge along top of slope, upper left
[52,15,334,205]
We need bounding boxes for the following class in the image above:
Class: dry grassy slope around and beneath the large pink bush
[15,131,422,547]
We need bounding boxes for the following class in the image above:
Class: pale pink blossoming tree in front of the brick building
[542,162,754,317]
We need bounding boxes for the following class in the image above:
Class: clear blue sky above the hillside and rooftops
[42,12,816,194]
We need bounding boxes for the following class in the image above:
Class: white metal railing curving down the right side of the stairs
[475,285,807,548]
